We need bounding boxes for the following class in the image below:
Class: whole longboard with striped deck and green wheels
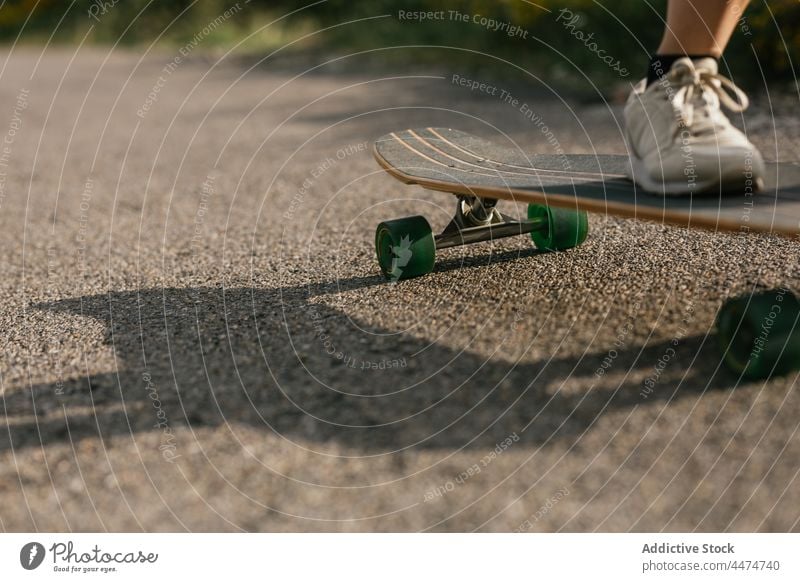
[374,127,800,378]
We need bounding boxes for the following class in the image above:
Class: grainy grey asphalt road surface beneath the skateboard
[0,48,800,531]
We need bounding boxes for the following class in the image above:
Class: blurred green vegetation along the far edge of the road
[0,0,800,85]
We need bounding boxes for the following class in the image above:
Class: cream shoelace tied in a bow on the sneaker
[669,66,750,128]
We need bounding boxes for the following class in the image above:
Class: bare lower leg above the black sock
[658,0,749,58]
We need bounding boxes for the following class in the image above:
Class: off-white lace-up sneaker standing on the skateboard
[625,57,764,195]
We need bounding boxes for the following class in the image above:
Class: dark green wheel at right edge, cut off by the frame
[717,289,800,380]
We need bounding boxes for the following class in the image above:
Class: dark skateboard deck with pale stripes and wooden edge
[374,127,800,236]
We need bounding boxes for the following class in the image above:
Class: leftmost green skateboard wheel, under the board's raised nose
[375,216,436,281]
